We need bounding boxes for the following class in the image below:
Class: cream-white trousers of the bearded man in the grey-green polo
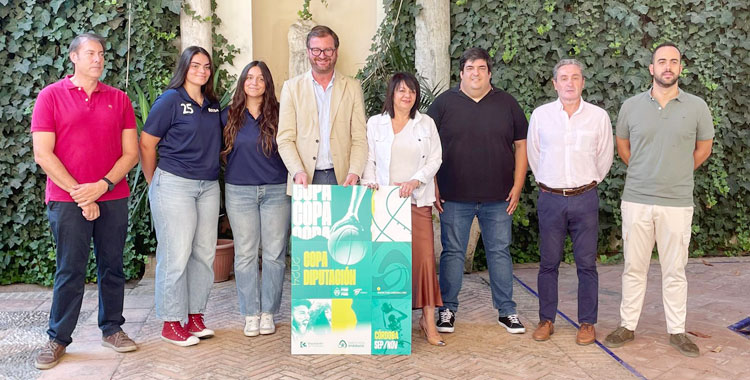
[620,201,693,334]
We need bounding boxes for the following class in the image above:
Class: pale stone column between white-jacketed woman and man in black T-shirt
[414,0,451,93]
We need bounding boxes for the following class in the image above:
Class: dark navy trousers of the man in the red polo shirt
[47,198,128,346]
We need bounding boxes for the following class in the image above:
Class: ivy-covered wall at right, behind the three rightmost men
[360,0,750,262]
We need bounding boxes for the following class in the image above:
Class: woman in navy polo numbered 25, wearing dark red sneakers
[140,46,221,346]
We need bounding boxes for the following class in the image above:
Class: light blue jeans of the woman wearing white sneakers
[225,183,292,315]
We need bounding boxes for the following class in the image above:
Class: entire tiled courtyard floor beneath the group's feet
[0,258,750,380]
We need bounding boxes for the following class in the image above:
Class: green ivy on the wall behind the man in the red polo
[0,0,180,285]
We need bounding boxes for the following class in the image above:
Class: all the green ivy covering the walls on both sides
[0,0,750,284]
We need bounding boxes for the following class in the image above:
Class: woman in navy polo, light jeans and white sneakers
[221,61,291,336]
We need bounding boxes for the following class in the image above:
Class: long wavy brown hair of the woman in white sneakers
[221,61,279,163]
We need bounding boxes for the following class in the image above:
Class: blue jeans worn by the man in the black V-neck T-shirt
[440,201,516,317]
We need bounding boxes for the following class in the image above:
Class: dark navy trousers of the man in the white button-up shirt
[537,189,599,324]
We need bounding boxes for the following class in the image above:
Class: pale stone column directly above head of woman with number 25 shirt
[180,0,213,53]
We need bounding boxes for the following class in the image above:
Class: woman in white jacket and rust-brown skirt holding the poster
[362,73,445,346]
